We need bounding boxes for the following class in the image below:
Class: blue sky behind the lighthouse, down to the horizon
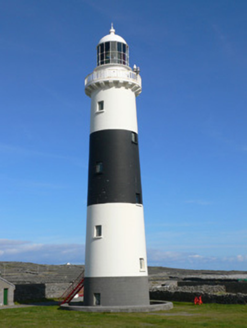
[0,0,247,270]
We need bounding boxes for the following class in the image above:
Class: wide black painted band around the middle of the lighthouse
[88,130,142,206]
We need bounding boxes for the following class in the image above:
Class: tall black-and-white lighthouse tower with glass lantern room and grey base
[84,26,149,306]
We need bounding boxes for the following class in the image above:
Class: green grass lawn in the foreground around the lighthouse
[0,303,247,328]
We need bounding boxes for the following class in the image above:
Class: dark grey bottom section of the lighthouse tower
[84,276,149,306]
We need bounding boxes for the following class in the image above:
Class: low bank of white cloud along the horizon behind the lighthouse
[0,239,247,271]
